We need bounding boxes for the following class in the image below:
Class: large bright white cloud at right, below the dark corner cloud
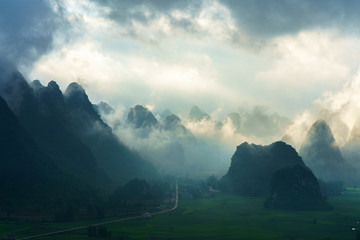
[250,29,360,114]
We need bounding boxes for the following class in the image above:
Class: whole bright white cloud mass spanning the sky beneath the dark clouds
[26,0,360,139]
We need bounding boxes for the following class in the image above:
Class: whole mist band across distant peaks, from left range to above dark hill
[94,103,290,178]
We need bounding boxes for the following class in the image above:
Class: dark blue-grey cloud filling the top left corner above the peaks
[0,0,61,65]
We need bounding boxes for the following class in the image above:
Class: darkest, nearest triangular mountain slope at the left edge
[0,94,82,213]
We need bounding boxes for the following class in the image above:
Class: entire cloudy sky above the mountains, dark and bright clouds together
[0,0,360,123]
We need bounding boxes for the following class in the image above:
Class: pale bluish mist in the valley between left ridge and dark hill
[97,107,231,177]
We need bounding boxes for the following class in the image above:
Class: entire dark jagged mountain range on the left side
[0,64,158,210]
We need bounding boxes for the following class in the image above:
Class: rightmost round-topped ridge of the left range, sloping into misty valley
[64,83,156,182]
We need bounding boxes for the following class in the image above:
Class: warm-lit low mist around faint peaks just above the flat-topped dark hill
[185,106,291,147]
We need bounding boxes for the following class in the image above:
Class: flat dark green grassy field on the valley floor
[0,189,360,240]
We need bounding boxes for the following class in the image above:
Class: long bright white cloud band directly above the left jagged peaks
[30,41,232,112]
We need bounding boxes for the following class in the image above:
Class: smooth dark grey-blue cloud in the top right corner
[221,0,360,37]
